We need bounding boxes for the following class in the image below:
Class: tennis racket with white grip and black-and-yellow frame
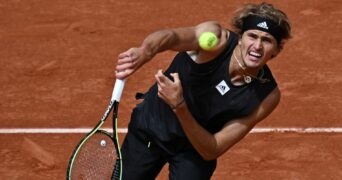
[67,79,125,180]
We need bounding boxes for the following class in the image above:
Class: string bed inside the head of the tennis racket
[71,132,118,180]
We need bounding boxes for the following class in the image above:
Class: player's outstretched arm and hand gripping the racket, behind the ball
[116,21,227,79]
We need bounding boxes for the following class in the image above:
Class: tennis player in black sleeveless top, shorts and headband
[116,3,291,180]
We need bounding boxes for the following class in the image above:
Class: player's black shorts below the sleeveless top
[122,130,216,180]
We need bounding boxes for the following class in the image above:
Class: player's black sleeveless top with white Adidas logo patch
[130,32,277,141]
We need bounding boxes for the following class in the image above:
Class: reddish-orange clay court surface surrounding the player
[0,0,342,180]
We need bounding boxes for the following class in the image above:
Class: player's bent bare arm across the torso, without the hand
[175,88,280,160]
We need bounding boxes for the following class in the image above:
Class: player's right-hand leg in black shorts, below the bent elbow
[169,150,216,180]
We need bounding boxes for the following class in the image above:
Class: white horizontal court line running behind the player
[0,127,342,134]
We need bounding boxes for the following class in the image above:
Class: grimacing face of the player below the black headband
[239,30,279,68]
